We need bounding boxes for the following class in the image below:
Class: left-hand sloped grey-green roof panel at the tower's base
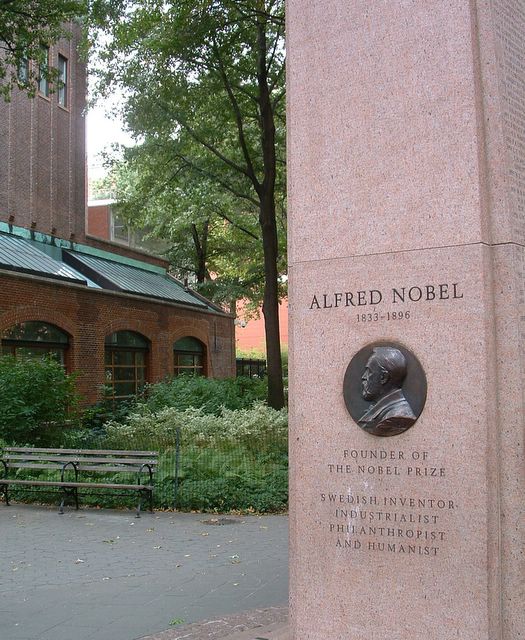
[0,233,86,284]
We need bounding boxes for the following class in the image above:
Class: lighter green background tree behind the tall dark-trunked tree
[104,139,286,310]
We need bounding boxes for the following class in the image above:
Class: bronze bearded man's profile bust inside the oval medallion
[358,346,417,436]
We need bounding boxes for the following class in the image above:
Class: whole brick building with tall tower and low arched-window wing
[0,27,235,402]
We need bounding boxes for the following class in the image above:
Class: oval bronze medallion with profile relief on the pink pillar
[343,342,427,436]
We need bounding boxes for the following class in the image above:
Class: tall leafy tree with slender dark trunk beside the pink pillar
[91,0,286,408]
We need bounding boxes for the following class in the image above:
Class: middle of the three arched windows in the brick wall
[104,331,148,400]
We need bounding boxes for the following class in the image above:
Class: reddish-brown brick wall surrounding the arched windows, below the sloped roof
[0,272,235,403]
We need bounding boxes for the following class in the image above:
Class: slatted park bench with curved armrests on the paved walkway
[0,447,158,517]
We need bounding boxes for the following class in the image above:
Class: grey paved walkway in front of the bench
[0,504,288,640]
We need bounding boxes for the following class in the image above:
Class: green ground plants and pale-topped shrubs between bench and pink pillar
[103,403,288,511]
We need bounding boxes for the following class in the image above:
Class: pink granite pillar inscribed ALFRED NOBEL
[287,0,525,640]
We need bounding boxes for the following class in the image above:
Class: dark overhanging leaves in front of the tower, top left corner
[0,0,88,100]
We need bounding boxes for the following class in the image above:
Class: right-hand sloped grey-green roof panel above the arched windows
[62,250,207,309]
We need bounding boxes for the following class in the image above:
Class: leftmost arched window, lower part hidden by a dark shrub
[2,320,69,364]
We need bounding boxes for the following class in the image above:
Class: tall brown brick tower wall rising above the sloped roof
[0,26,86,242]
